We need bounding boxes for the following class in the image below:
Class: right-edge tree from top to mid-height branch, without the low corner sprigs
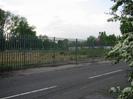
[109,0,133,64]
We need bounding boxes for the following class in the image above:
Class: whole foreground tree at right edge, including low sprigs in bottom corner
[108,0,133,99]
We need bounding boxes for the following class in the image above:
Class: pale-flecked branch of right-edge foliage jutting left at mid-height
[108,33,133,66]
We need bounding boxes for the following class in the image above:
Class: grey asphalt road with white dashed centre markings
[0,62,127,99]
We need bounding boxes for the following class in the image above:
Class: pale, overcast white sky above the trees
[0,0,120,39]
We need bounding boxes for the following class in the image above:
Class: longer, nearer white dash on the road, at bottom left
[0,86,57,99]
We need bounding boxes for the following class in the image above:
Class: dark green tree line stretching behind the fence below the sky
[0,9,119,51]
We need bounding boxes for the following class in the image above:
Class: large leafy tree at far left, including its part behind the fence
[0,9,38,50]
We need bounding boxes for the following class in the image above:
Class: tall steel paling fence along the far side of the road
[0,34,106,72]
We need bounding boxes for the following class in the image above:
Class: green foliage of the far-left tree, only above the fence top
[0,9,36,36]
